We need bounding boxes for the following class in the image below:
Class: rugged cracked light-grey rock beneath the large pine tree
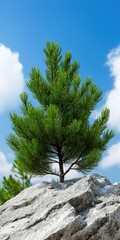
[0,174,120,240]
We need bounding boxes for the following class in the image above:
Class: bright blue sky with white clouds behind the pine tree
[0,0,120,182]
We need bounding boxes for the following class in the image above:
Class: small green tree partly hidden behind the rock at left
[0,160,31,205]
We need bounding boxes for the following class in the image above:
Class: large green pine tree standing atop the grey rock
[7,42,113,182]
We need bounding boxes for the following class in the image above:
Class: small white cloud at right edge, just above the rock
[100,142,120,168]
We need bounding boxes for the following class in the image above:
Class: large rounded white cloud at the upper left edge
[0,44,24,112]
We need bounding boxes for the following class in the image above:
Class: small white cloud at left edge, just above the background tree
[0,152,12,178]
